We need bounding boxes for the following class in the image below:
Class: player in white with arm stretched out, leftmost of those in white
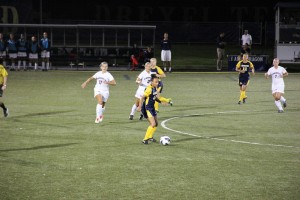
[81,62,117,124]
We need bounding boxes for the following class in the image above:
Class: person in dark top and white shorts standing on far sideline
[160,33,172,72]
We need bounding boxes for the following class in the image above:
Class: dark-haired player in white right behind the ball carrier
[129,62,151,120]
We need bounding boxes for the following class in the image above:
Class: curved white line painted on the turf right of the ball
[161,110,300,148]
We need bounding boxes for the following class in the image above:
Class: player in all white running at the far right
[265,58,288,113]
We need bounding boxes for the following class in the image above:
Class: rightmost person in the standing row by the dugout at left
[40,32,51,71]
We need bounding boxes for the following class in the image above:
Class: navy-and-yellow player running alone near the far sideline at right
[235,54,254,104]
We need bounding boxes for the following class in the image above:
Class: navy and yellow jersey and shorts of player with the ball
[142,85,157,118]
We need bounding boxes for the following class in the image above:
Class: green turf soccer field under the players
[0,69,300,200]
